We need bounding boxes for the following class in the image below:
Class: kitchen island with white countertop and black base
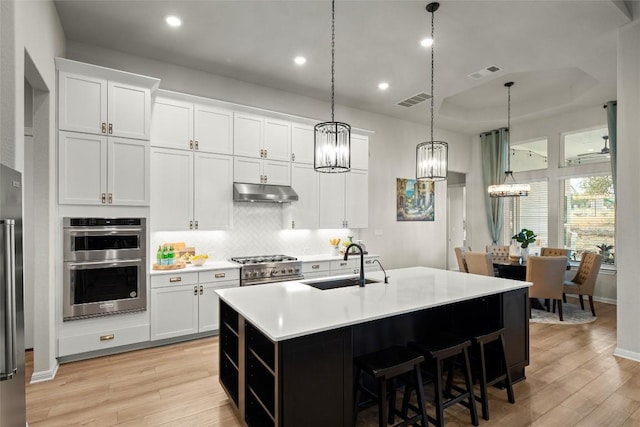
[217,267,531,426]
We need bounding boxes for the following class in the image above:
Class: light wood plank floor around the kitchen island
[27,303,640,427]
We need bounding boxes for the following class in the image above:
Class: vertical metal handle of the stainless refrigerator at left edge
[0,219,18,381]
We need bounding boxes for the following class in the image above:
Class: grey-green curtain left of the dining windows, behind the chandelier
[480,128,508,245]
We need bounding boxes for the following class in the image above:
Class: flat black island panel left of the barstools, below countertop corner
[279,328,353,427]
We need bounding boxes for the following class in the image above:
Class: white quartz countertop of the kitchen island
[216,267,532,341]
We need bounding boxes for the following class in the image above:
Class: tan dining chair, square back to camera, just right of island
[526,256,567,321]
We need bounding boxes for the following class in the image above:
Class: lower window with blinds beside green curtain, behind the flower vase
[503,181,549,247]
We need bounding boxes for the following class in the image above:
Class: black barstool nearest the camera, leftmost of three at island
[353,346,427,427]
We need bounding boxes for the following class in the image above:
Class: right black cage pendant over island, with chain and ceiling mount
[416,3,449,181]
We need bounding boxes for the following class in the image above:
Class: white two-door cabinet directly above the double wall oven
[58,132,150,206]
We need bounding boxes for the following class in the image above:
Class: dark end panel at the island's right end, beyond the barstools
[502,288,529,382]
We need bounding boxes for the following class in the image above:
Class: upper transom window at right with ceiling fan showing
[564,127,610,166]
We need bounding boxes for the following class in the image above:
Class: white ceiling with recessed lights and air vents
[55,0,635,132]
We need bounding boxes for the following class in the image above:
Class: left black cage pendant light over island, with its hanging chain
[313,0,351,173]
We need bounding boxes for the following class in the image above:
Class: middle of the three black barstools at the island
[402,335,478,427]
